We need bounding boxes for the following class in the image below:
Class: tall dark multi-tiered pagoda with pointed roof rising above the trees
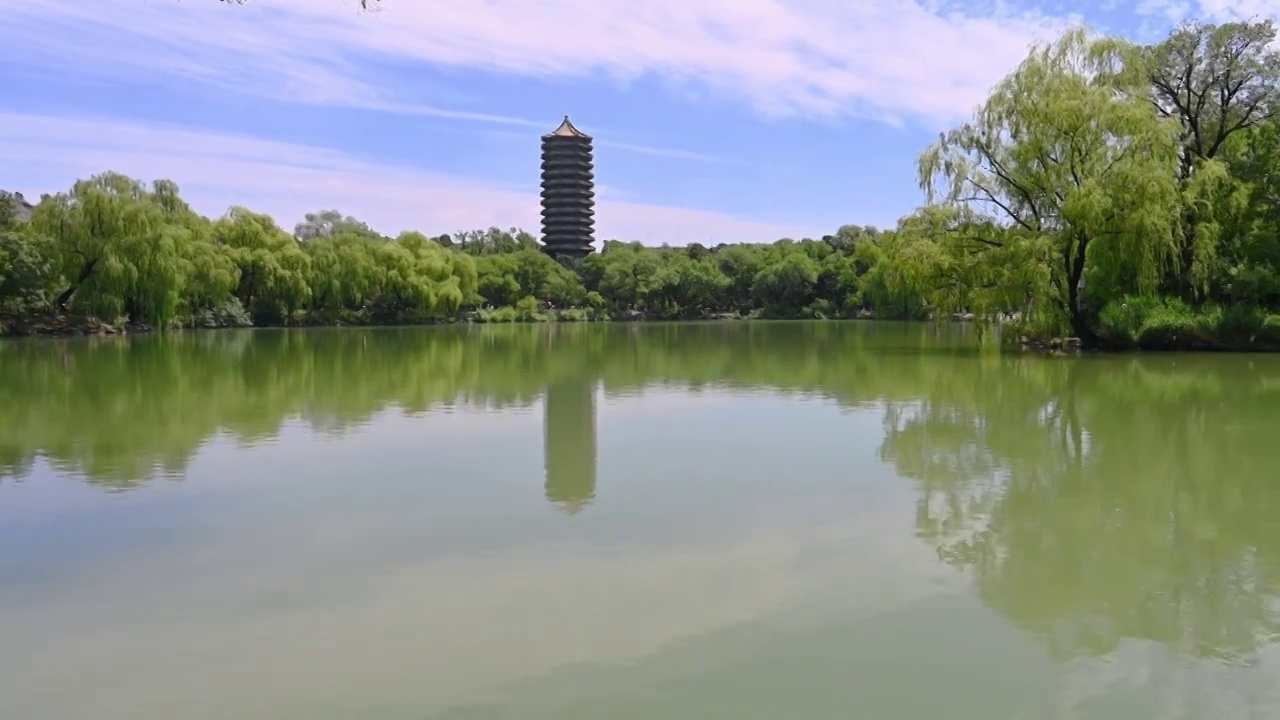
[543,115,595,259]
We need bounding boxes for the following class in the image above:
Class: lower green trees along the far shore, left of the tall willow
[0,181,924,328]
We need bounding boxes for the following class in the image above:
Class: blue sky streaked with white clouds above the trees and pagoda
[0,0,1264,245]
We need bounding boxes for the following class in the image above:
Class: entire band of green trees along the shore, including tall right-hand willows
[0,22,1280,347]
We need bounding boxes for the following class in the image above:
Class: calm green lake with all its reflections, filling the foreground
[0,323,1280,720]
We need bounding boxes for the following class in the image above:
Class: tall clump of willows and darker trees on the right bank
[891,22,1280,347]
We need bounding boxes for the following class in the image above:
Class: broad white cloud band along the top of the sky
[0,0,1066,123]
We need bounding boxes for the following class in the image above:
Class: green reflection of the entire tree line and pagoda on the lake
[0,323,1280,664]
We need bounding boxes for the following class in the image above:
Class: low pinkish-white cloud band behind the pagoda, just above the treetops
[0,113,832,245]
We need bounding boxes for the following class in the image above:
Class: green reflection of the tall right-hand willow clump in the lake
[881,356,1280,664]
